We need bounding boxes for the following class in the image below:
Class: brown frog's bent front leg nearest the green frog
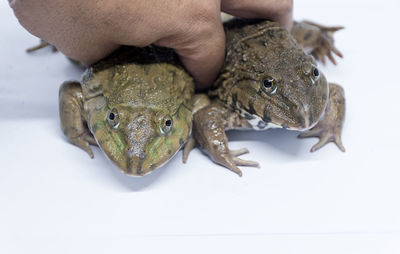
[193,102,259,176]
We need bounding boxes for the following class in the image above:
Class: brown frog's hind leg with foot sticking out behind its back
[291,21,344,65]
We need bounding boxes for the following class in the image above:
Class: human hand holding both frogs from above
[9,0,293,89]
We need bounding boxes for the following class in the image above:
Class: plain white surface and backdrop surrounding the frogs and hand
[0,0,400,254]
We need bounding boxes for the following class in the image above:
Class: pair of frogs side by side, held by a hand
[54,19,345,176]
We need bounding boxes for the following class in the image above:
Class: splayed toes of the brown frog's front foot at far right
[298,126,346,152]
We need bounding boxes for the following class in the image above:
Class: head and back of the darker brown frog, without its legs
[212,22,329,130]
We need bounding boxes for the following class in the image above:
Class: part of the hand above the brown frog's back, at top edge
[221,0,293,29]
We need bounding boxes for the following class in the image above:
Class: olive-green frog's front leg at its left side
[59,81,97,158]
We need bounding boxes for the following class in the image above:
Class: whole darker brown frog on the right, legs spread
[183,18,345,176]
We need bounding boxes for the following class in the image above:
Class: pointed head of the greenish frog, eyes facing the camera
[85,96,192,176]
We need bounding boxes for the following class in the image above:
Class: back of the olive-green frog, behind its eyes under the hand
[82,46,194,112]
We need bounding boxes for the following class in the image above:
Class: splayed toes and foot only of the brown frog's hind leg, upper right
[304,21,344,65]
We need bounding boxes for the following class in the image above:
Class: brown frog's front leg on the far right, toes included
[298,83,345,152]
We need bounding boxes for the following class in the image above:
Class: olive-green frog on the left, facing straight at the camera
[59,46,206,176]
